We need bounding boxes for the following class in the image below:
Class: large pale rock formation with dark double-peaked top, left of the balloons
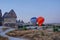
[3,9,17,27]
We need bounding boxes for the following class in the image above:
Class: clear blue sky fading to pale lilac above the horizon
[0,0,60,23]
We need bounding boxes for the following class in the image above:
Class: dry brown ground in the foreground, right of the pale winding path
[6,30,60,40]
